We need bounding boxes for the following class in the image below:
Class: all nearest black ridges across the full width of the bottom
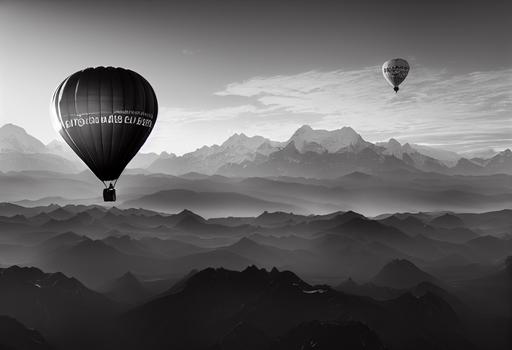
[0,260,511,350]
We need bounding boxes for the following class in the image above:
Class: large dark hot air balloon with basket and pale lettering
[51,67,158,201]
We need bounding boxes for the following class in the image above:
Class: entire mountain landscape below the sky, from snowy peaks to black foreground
[0,121,512,349]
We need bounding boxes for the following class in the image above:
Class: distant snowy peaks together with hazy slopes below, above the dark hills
[0,124,512,217]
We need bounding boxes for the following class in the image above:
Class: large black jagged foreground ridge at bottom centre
[120,267,468,349]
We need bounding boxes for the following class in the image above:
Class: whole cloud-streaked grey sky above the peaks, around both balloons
[0,0,512,154]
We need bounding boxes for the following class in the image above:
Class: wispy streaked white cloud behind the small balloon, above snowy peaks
[216,67,512,151]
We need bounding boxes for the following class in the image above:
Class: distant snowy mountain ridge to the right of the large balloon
[143,125,512,178]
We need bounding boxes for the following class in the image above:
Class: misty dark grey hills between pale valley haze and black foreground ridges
[0,203,512,288]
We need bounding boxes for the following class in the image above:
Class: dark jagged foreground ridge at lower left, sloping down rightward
[0,266,118,349]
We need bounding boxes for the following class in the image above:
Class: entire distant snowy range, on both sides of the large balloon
[0,124,512,178]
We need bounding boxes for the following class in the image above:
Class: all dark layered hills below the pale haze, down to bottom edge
[0,200,512,350]
